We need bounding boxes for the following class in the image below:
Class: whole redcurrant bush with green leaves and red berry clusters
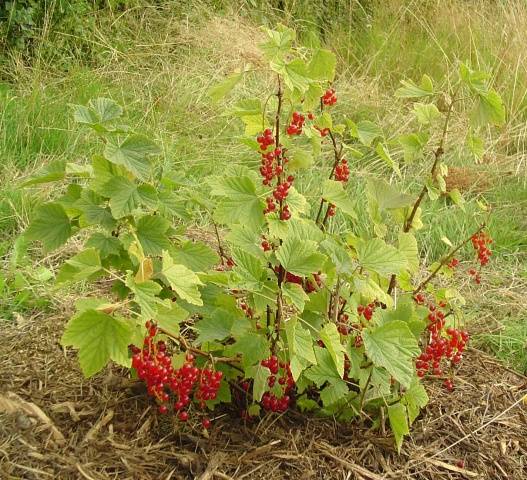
[21,26,504,449]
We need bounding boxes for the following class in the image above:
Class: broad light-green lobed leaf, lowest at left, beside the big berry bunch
[61,310,132,377]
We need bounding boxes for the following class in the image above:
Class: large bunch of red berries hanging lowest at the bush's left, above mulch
[130,321,223,428]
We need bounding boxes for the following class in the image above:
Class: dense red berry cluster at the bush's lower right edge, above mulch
[415,302,469,391]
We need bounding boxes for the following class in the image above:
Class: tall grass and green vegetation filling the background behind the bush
[0,0,527,371]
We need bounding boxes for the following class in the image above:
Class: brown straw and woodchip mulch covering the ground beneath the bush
[0,310,527,480]
